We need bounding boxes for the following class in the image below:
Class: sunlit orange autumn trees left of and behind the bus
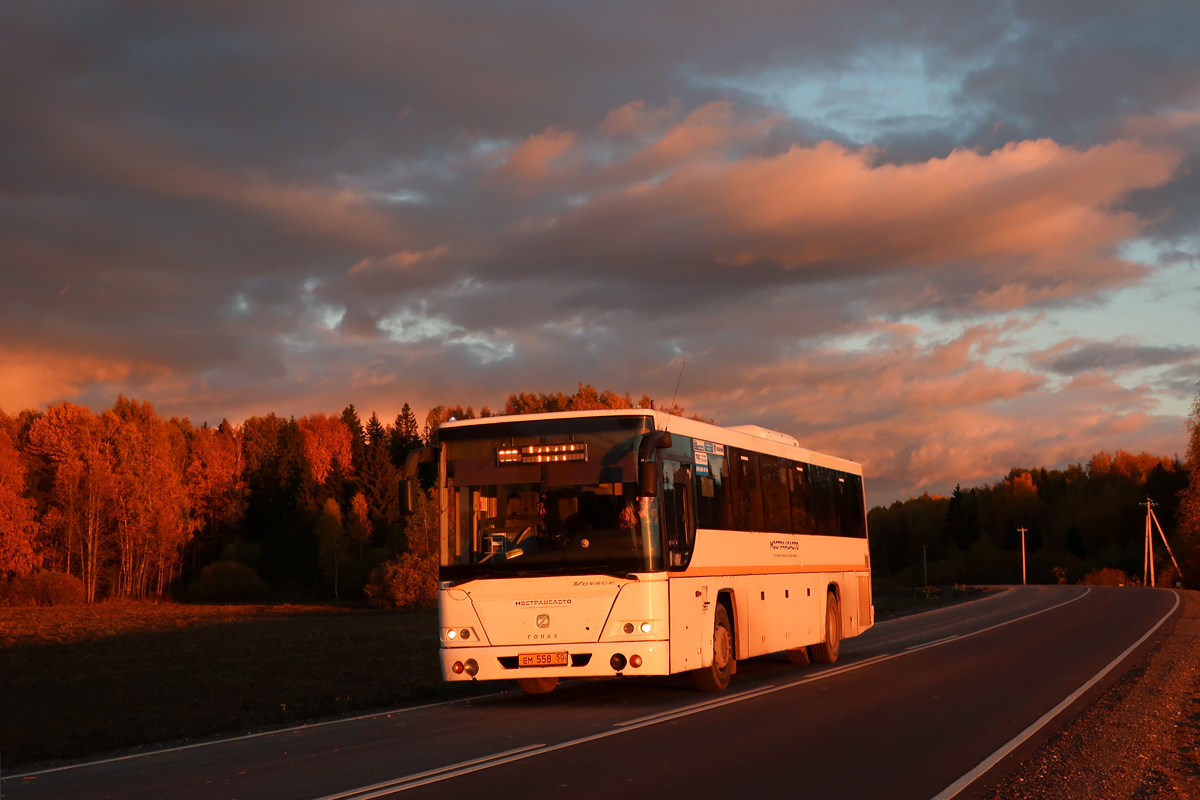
[0,383,683,602]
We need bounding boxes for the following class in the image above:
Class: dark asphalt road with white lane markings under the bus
[2,587,1177,800]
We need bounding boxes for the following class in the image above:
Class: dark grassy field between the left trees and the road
[0,603,500,770]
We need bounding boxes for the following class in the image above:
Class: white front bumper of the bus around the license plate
[442,639,671,680]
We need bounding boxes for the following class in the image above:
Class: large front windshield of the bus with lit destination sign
[439,416,662,581]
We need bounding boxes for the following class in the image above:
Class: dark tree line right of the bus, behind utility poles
[868,451,1200,587]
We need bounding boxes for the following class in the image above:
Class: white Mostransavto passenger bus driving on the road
[402,409,874,693]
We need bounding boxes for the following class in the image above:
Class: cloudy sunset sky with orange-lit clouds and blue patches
[0,0,1200,504]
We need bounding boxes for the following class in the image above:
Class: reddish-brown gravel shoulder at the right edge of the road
[961,591,1200,800]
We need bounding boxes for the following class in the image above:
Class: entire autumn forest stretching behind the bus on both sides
[0,383,1200,606]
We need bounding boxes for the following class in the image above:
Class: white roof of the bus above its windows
[438,408,863,475]
